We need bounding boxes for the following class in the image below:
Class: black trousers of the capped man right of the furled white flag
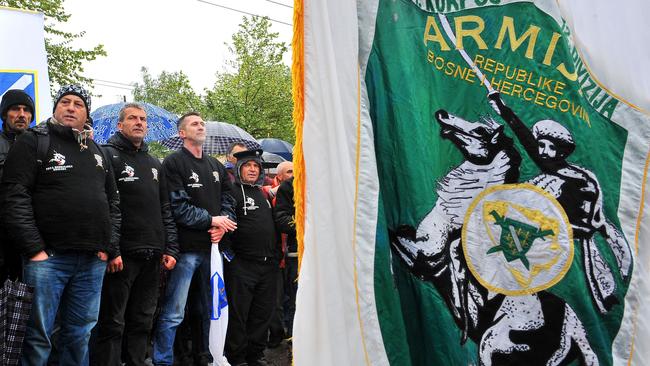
[224,256,280,365]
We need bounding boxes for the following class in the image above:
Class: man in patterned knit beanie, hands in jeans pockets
[2,85,120,365]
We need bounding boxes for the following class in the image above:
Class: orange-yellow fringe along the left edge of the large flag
[291,0,306,273]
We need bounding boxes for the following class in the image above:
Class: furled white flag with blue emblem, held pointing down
[210,245,228,366]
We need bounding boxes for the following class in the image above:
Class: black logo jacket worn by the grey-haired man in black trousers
[104,132,179,258]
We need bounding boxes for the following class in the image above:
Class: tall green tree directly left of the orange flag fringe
[205,17,295,142]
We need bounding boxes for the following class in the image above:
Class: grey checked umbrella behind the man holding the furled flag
[162,122,260,155]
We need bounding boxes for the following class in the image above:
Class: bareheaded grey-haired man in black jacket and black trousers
[90,103,179,366]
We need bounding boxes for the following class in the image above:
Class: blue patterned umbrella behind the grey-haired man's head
[90,103,178,144]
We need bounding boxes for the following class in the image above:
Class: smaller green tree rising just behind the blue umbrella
[133,67,205,114]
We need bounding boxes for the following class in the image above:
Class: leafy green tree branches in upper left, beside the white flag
[0,0,106,92]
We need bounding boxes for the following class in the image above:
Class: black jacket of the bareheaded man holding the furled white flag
[163,147,237,252]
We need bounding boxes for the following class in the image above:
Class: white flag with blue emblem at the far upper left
[0,7,52,122]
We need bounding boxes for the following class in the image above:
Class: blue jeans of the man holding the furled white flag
[153,252,211,365]
